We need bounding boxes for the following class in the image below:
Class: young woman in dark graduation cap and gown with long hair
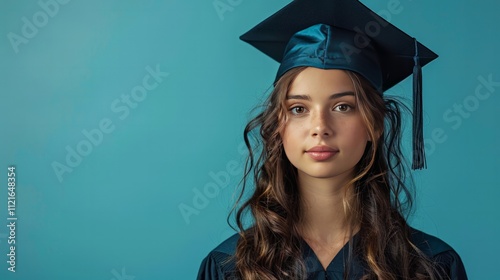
[198,0,467,280]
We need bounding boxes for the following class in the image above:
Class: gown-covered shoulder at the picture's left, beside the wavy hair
[197,233,240,280]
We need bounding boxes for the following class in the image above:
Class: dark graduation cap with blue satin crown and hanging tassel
[240,0,437,169]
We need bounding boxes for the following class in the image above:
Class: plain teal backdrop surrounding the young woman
[0,0,500,280]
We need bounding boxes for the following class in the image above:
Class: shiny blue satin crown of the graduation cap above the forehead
[275,24,383,93]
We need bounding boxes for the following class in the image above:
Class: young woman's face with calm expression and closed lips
[281,67,368,182]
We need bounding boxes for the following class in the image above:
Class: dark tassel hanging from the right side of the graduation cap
[412,39,427,170]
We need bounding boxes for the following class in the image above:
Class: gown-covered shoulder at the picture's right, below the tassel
[411,228,467,280]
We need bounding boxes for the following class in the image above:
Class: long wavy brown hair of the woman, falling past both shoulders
[230,67,442,280]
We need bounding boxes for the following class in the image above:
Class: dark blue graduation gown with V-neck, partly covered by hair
[197,230,467,280]
